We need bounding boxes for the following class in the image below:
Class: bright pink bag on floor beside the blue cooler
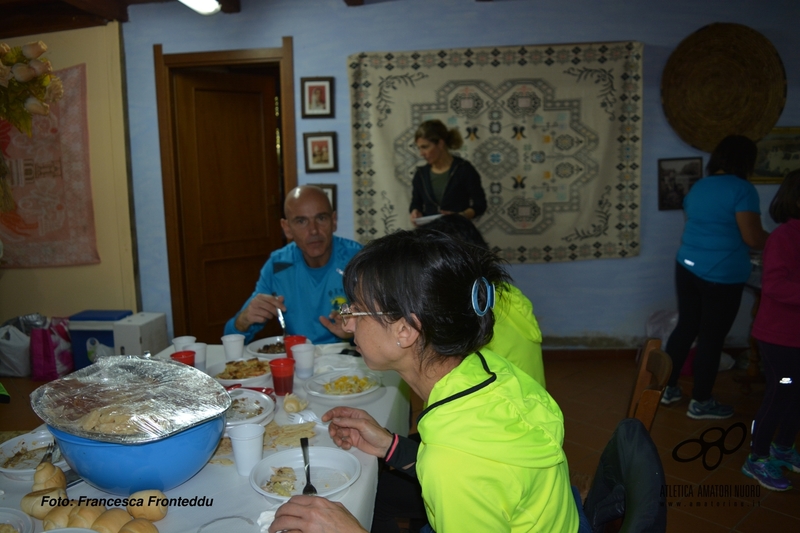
[31,318,73,381]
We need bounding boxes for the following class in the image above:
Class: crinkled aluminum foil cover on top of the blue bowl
[31,356,231,444]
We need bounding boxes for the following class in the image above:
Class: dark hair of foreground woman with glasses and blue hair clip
[344,230,510,362]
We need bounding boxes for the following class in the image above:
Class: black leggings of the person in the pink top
[751,341,800,457]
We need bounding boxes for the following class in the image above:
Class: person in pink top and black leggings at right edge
[742,170,800,490]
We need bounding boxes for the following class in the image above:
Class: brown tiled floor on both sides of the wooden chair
[545,355,800,533]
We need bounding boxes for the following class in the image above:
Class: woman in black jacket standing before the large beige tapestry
[409,120,486,225]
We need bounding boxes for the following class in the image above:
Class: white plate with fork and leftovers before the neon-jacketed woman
[250,446,361,501]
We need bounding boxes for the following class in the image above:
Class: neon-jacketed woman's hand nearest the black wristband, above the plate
[322,407,394,457]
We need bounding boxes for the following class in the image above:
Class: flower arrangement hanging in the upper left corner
[0,41,64,257]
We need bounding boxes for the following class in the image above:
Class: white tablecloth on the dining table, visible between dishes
[0,345,409,533]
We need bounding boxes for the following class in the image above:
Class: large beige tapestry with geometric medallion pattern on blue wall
[348,42,643,263]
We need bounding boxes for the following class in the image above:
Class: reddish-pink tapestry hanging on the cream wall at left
[0,64,100,268]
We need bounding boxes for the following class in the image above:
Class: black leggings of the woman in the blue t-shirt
[666,263,744,402]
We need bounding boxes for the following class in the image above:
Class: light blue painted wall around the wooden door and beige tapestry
[123,0,800,346]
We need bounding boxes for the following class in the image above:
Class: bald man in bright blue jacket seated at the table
[225,185,361,344]
